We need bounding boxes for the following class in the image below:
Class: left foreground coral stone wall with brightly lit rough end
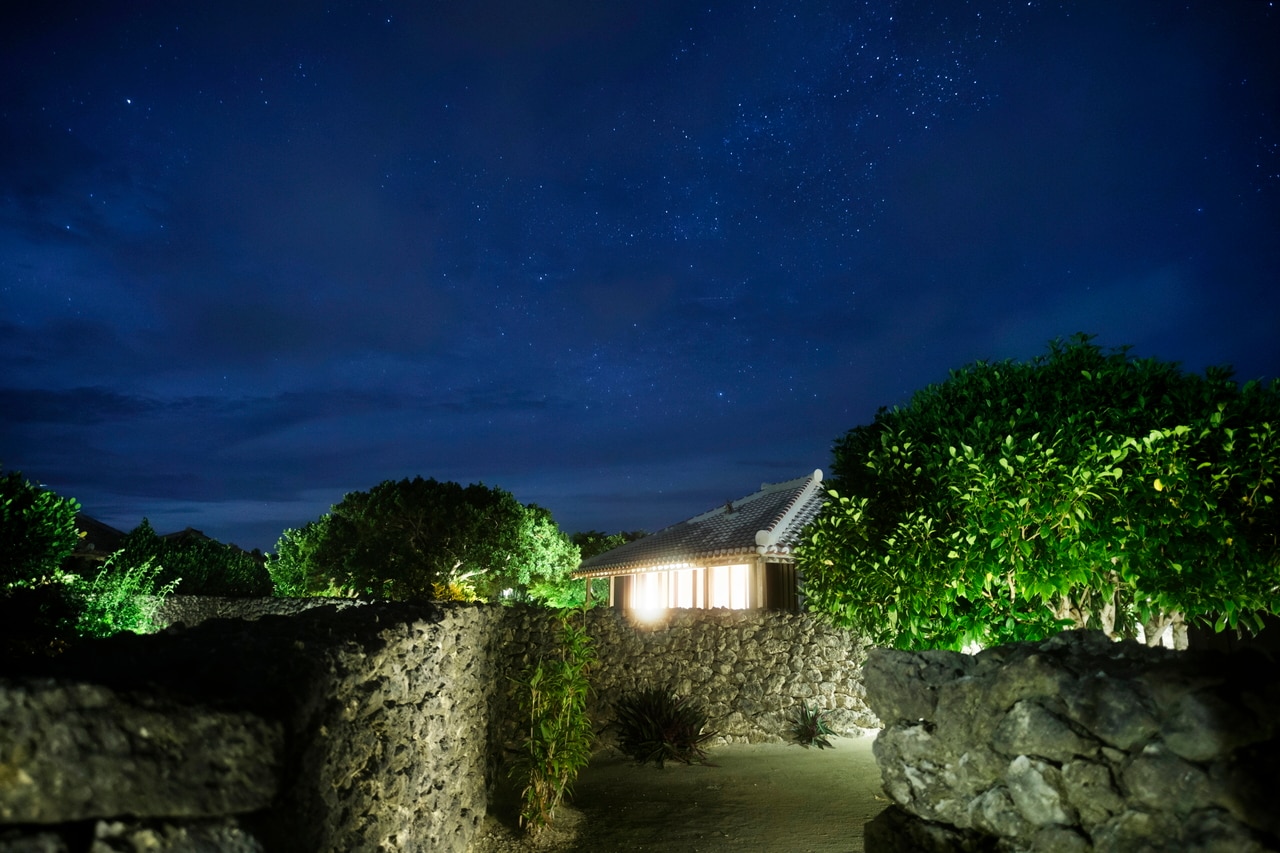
[0,605,500,853]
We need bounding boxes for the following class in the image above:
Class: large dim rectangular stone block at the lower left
[0,679,283,824]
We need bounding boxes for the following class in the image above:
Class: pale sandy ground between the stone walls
[471,736,888,853]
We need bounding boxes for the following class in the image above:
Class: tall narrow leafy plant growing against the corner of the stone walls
[511,611,595,834]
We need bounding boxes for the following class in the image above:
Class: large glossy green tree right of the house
[797,336,1280,647]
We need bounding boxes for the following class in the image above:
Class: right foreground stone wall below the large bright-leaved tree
[865,631,1280,853]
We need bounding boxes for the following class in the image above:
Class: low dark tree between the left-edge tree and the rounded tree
[113,519,271,598]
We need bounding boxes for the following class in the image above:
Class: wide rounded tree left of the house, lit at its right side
[271,476,579,601]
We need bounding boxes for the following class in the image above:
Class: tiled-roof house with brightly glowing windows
[573,470,827,611]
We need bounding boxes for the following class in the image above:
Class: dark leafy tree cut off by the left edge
[0,471,79,590]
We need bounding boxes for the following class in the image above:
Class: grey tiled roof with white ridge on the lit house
[573,469,827,578]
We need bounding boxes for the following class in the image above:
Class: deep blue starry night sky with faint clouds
[0,0,1280,549]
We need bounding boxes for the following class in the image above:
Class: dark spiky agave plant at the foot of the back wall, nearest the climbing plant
[614,688,717,767]
